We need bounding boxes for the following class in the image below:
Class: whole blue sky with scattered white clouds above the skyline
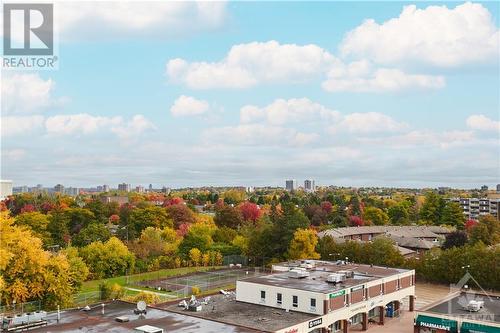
[1,1,500,188]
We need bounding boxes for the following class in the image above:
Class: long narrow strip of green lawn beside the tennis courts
[80,267,222,293]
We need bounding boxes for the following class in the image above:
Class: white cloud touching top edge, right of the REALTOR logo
[55,1,227,40]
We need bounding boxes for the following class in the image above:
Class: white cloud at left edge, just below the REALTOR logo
[2,74,64,115]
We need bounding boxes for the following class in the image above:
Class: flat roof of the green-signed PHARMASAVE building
[422,292,500,323]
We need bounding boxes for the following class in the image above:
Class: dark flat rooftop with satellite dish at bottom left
[26,301,256,333]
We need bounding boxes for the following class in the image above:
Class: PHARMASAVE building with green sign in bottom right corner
[414,291,500,333]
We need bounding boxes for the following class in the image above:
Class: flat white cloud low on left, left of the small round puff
[45,113,122,135]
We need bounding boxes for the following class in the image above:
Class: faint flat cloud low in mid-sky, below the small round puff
[202,124,319,147]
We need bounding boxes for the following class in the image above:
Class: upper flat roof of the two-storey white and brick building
[241,260,408,294]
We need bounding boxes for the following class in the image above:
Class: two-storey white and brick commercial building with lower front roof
[167,260,415,333]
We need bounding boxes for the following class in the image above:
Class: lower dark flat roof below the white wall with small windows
[165,295,318,332]
